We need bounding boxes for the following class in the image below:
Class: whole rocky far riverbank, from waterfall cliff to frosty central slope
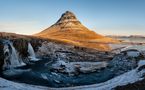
[0,33,114,74]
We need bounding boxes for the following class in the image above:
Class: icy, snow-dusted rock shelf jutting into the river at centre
[52,61,107,75]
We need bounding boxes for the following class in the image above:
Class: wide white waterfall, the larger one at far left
[3,42,25,68]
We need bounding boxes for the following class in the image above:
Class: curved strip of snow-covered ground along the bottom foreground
[0,60,145,90]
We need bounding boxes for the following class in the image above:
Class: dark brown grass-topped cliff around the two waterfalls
[0,32,48,72]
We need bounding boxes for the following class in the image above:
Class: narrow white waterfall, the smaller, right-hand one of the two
[28,43,39,61]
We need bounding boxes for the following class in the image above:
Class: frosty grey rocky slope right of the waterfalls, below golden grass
[37,42,114,62]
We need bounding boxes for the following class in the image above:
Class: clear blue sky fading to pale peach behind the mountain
[0,0,145,35]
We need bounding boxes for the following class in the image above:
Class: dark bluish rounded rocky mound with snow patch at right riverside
[109,50,145,75]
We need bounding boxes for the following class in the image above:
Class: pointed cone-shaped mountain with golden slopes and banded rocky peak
[35,11,117,50]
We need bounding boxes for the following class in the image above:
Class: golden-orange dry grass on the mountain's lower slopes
[35,24,118,51]
